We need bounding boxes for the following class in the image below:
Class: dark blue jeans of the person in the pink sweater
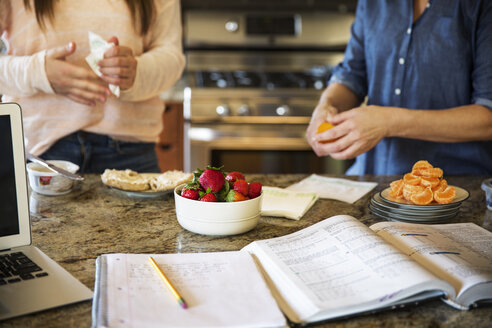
[40,131,161,173]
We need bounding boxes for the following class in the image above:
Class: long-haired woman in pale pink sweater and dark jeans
[0,0,185,173]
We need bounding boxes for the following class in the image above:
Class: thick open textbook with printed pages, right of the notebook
[244,215,492,323]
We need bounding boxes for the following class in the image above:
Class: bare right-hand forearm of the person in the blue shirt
[387,105,492,142]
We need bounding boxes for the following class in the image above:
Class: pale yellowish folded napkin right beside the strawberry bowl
[261,186,318,220]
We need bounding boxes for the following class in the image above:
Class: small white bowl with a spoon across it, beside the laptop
[27,160,79,196]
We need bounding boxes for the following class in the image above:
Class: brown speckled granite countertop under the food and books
[0,174,492,328]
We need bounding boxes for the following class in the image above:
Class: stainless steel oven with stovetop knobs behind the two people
[183,5,353,173]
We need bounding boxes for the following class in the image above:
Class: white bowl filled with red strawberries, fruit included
[174,166,262,236]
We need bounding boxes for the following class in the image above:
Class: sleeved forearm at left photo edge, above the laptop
[0,51,53,97]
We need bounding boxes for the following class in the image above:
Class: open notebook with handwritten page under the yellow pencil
[96,252,287,327]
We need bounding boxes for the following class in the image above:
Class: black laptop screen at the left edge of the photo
[0,115,19,237]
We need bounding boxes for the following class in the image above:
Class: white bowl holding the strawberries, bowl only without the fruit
[174,184,263,236]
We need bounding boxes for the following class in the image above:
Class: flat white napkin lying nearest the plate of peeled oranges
[287,174,378,204]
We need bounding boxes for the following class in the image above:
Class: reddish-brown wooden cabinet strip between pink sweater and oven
[156,102,184,172]
